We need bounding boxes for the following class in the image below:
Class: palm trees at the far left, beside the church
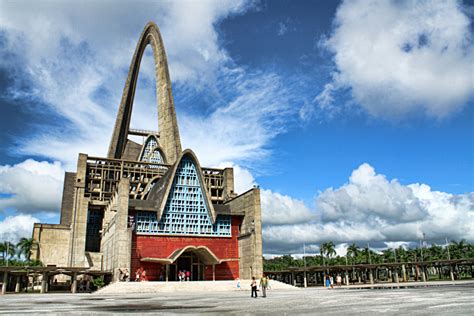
[0,237,42,266]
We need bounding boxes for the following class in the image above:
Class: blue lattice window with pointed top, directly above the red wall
[136,157,231,236]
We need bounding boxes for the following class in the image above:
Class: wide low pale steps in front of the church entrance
[93,280,298,295]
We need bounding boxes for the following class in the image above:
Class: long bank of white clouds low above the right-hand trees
[263,164,474,254]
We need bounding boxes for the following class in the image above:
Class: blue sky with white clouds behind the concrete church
[0,0,474,256]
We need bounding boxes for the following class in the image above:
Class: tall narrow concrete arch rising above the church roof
[108,22,182,164]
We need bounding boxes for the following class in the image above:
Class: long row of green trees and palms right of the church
[263,240,474,271]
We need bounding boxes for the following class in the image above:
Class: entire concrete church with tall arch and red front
[32,23,262,280]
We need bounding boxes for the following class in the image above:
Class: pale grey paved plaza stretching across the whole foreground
[0,283,474,315]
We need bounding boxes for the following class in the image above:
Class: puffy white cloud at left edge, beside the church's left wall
[0,159,64,212]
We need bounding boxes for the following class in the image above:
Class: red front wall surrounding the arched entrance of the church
[131,217,241,281]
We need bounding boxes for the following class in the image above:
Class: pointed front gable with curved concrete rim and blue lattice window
[136,150,231,237]
